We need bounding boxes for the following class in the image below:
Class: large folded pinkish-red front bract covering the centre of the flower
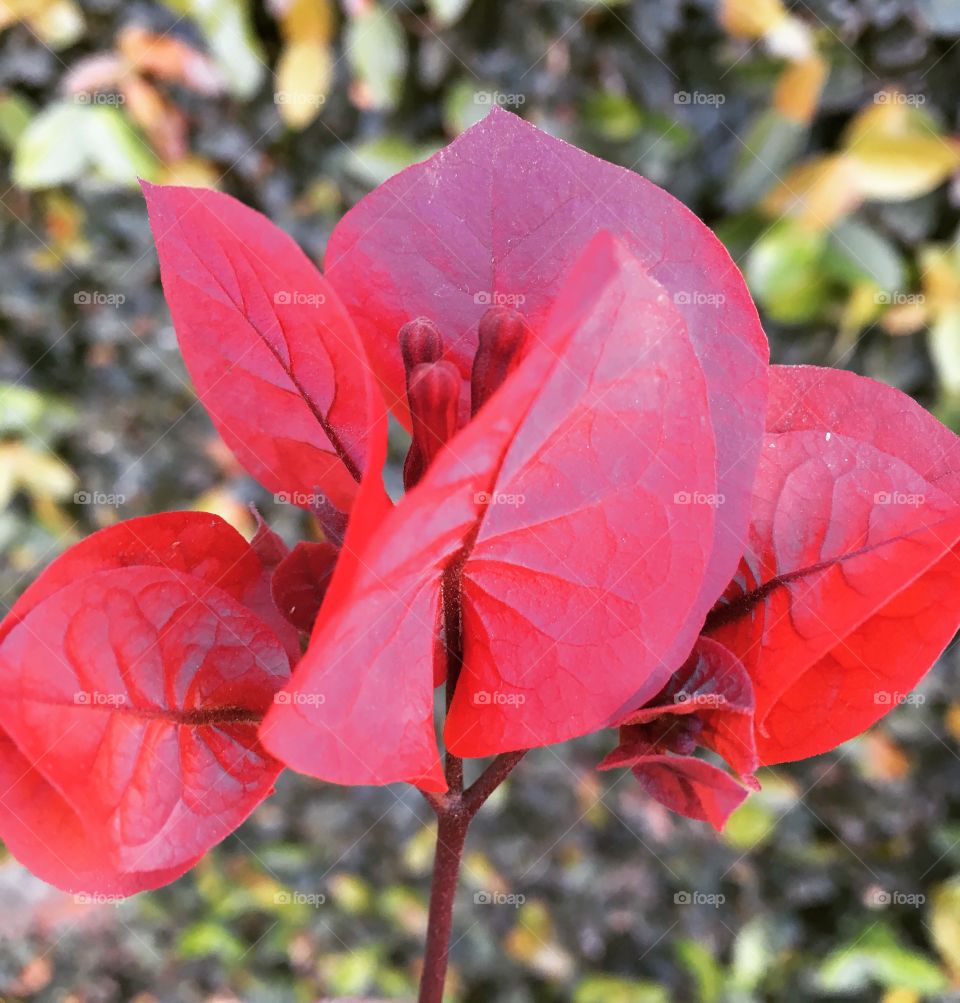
[263,235,714,783]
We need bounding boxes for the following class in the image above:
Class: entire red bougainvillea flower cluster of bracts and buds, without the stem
[0,111,960,895]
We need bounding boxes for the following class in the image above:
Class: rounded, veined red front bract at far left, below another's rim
[0,567,289,894]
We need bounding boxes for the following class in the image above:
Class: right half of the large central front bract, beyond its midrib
[445,235,715,756]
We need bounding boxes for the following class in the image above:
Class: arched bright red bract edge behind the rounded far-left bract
[0,512,300,659]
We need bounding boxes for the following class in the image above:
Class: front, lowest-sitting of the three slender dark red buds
[403,361,461,490]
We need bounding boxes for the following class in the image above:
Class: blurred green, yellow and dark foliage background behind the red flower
[0,0,960,1003]
